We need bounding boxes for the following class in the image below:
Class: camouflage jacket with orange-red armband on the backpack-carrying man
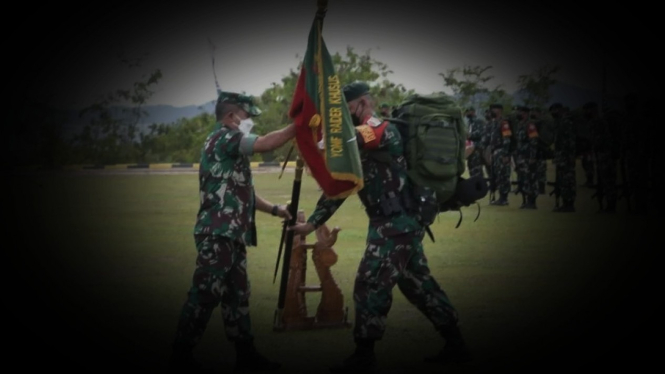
[307,118,422,237]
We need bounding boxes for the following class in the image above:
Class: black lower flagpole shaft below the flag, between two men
[274,150,305,328]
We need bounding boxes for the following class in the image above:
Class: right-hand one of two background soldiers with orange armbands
[515,106,538,209]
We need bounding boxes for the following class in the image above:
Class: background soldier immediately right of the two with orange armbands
[549,103,577,213]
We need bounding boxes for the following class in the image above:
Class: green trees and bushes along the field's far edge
[16,46,559,168]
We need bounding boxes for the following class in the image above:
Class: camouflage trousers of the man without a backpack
[175,235,253,346]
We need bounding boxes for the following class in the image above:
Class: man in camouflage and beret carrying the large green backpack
[289,82,469,372]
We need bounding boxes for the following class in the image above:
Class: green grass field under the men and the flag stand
[5,164,663,373]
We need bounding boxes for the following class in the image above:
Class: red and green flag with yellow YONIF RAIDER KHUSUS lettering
[289,1,363,199]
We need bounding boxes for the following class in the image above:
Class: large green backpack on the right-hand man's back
[375,93,487,231]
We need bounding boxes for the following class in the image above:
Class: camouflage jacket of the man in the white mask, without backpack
[194,123,257,245]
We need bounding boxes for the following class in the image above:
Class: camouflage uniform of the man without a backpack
[176,123,256,345]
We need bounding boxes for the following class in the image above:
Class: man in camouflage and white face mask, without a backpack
[170,92,295,372]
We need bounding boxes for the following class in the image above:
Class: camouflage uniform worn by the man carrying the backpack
[307,118,458,342]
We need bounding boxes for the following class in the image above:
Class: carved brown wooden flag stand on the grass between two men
[273,210,351,331]
